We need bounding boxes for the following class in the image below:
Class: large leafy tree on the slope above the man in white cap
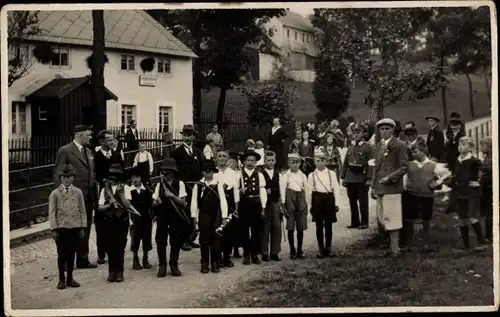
[312,8,446,124]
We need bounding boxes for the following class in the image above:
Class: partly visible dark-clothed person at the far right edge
[480,137,493,242]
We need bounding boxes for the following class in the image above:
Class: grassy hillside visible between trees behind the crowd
[202,76,491,131]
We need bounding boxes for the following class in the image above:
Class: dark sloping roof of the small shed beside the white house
[26,76,118,101]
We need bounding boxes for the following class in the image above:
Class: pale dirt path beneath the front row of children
[11,196,375,309]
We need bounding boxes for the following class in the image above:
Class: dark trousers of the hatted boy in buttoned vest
[239,197,263,256]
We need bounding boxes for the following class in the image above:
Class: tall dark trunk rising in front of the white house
[91,10,107,146]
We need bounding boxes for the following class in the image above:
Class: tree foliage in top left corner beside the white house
[7,11,40,87]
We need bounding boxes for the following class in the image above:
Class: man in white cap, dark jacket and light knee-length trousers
[371,118,409,256]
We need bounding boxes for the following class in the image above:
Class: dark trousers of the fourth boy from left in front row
[155,221,182,265]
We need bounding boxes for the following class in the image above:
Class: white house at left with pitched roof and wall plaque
[9,10,196,137]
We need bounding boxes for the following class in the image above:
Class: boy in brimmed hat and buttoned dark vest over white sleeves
[237,151,267,265]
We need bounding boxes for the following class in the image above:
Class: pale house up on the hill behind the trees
[253,11,318,82]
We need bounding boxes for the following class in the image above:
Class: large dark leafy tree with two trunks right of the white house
[149,9,285,123]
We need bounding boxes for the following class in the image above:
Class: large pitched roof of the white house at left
[23,10,197,57]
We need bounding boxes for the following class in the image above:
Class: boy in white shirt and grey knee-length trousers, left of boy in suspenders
[280,153,310,260]
